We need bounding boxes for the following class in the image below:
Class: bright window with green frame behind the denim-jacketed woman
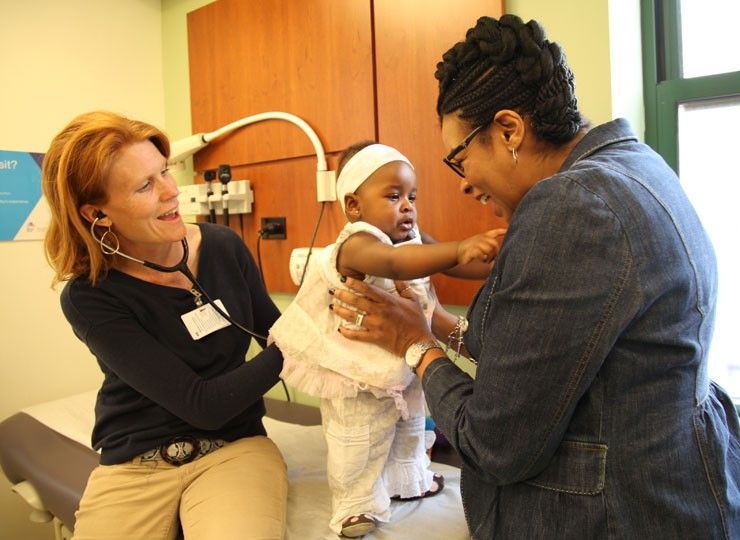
[641,0,740,401]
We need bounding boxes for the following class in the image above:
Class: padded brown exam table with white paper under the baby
[0,391,462,540]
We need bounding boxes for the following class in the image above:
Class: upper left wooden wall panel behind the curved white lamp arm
[188,0,375,169]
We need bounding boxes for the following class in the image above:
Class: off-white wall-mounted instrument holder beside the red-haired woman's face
[177,180,254,216]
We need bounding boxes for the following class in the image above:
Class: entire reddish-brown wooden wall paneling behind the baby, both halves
[188,0,503,304]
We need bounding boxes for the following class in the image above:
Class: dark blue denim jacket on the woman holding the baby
[423,120,740,540]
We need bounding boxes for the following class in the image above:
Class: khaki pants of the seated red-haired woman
[74,437,288,540]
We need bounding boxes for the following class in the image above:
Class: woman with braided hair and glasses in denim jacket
[333,15,740,540]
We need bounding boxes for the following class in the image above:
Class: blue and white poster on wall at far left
[0,150,49,240]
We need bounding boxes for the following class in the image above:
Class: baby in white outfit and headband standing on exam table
[270,143,501,538]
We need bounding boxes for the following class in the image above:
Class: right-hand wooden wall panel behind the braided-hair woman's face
[373,0,503,305]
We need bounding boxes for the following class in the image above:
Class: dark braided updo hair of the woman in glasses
[434,15,585,145]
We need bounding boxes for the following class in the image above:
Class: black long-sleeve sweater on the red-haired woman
[61,224,282,465]
